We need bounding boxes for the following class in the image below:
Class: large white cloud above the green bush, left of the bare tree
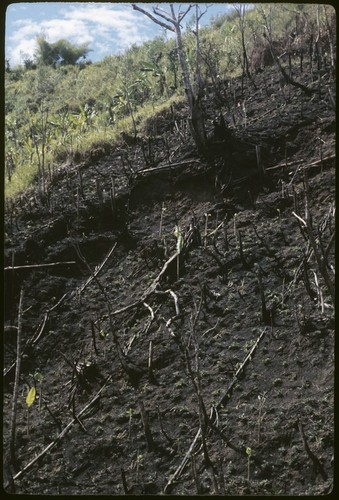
[6,3,159,65]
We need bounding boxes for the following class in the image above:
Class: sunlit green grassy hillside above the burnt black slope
[5,4,335,197]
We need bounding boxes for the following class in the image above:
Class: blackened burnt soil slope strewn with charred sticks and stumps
[3,63,336,496]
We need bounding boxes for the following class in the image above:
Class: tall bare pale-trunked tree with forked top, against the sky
[132,4,207,154]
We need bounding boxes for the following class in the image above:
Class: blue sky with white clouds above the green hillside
[5,2,230,66]
